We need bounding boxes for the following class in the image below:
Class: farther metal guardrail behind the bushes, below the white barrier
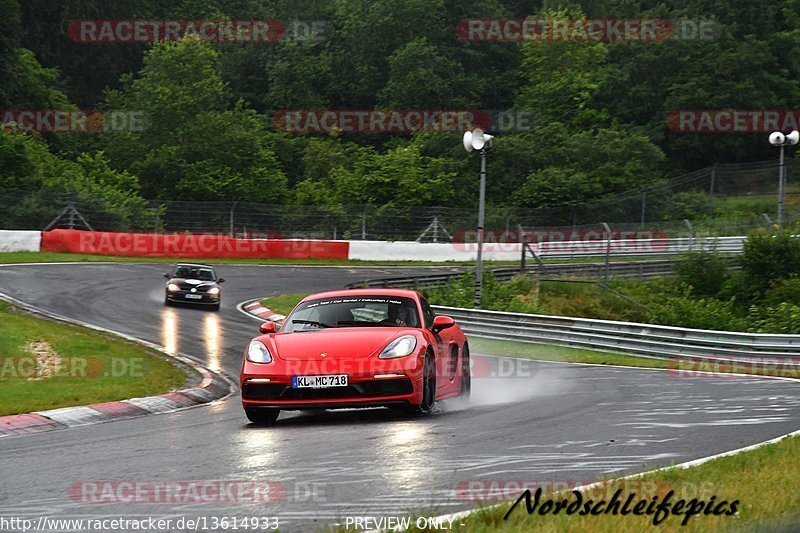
[347,257,738,289]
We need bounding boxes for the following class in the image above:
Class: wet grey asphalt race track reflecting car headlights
[0,263,800,531]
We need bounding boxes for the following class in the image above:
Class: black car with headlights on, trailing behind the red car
[164,263,225,310]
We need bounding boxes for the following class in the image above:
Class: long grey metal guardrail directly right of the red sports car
[434,306,800,359]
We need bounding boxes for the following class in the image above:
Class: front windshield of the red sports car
[283,295,420,332]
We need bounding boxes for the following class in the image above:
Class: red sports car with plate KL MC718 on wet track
[241,289,471,424]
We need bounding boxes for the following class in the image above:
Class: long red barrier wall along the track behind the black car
[42,229,350,259]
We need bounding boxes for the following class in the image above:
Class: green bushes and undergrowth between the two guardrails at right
[426,233,800,334]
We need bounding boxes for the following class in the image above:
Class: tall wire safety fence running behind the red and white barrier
[0,158,800,239]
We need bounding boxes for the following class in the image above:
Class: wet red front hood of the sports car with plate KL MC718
[272,327,417,361]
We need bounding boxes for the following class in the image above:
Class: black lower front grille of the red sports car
[242,378,414,401]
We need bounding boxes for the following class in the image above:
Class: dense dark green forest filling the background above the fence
[0,0,800,214]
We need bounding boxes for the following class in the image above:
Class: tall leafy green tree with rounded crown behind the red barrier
[101,39,287,203]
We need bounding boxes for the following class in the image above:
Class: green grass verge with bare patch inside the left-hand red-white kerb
[0,301,192,415]
